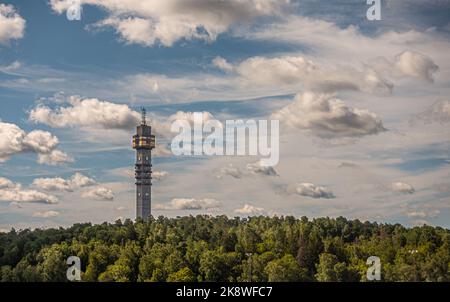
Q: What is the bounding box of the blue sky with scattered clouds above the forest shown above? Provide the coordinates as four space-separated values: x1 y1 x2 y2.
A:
0 0 450 230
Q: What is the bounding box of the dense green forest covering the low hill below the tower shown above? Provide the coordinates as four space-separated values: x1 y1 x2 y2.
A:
0 215 450 282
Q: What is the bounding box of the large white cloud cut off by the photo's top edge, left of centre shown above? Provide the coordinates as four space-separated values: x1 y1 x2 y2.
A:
50 0 289 47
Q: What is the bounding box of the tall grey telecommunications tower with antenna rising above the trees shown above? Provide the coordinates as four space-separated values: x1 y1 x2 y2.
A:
133 108 155 221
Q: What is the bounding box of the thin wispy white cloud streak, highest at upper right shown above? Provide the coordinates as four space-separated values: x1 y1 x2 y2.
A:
246 15 442 63
